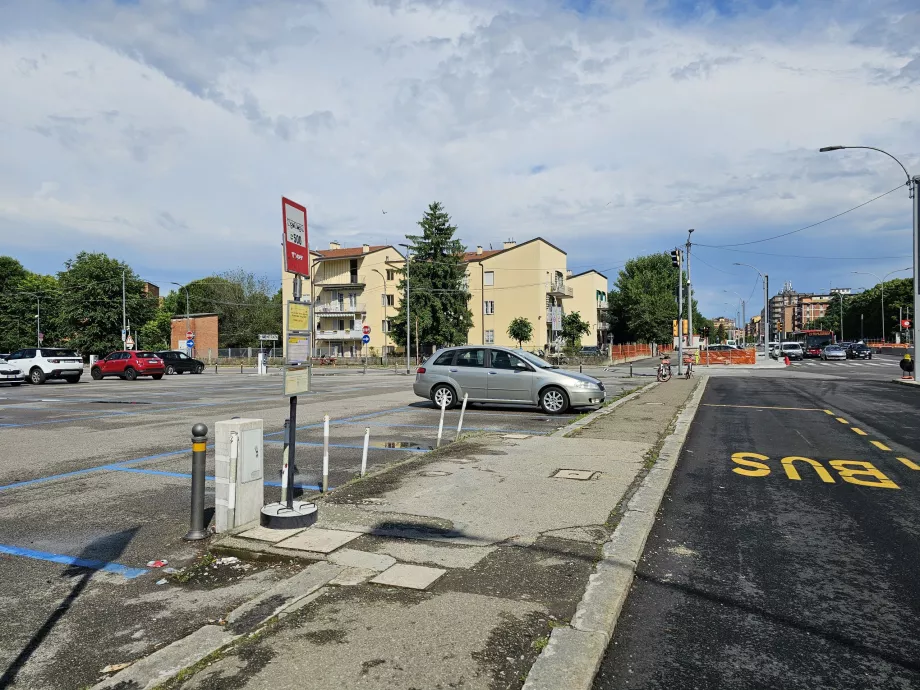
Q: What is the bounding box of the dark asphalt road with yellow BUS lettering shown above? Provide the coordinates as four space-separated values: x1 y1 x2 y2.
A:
595 372 920 690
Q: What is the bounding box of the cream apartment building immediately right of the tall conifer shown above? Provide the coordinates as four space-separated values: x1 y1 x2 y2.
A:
464 237 574 349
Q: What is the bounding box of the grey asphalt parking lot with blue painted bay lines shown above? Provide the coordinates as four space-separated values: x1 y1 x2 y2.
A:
0 370 643 688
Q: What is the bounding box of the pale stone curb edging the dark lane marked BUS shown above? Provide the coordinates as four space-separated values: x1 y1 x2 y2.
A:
522 376 709 690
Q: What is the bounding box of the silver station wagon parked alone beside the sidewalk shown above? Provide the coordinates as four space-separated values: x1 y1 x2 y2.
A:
413 345 607 414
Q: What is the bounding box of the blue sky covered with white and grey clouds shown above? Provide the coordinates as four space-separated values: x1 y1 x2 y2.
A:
0 0 920 316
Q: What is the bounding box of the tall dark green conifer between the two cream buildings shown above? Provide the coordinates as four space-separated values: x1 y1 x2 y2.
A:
389 201 473 351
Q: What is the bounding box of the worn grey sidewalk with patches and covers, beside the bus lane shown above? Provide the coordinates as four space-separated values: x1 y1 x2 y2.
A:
97 379 705 690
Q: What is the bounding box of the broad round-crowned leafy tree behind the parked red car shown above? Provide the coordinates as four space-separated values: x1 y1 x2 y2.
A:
58 252 157 355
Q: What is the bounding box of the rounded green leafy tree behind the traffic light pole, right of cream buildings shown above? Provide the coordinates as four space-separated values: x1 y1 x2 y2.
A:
608 253 710 343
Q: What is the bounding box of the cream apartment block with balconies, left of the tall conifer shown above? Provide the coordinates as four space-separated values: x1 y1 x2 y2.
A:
282 242 405 357
